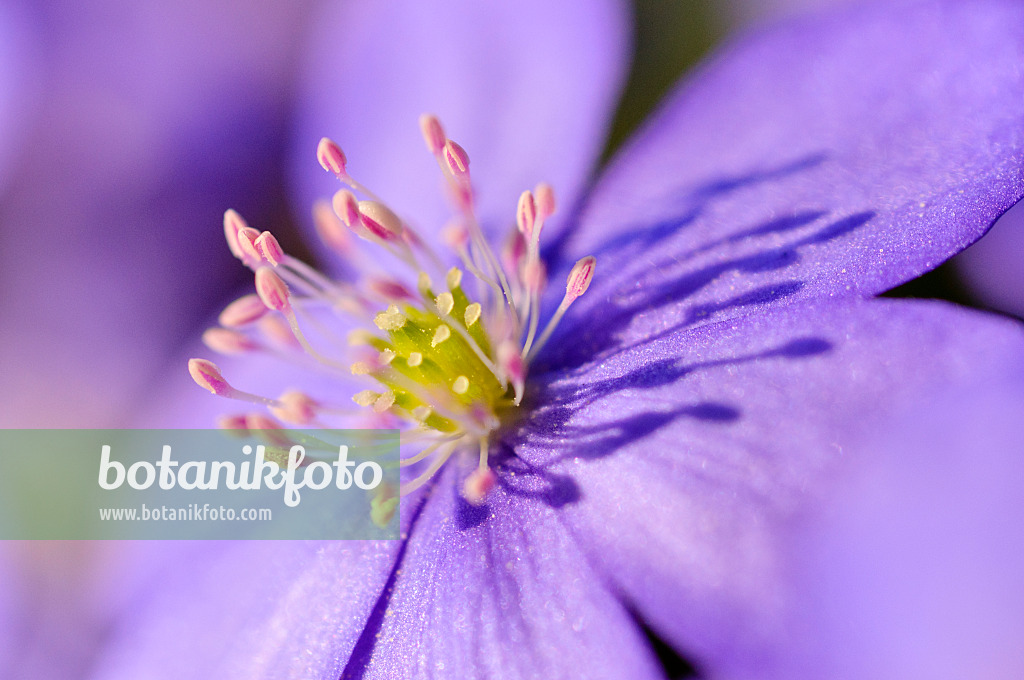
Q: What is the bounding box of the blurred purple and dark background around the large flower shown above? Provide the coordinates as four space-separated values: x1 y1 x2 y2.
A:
0 0 1024 677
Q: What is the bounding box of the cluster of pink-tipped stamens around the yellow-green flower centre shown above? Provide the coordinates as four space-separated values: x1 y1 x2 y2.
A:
188 116 595 507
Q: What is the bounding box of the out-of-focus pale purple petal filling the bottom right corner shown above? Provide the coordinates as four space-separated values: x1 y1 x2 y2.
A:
750 374 1024 680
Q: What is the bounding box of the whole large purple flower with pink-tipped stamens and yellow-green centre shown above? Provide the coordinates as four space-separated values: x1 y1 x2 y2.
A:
0 0 1024 680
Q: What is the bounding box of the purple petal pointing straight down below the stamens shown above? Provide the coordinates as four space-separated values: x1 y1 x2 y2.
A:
346 462 662 679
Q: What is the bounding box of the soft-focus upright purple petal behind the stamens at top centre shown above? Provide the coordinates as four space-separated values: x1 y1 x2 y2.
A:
294 0 628 260
